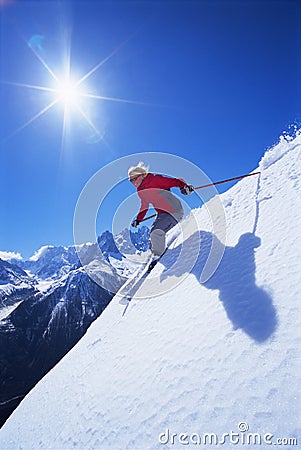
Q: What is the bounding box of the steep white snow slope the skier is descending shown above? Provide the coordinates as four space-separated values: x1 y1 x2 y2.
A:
0 135 301 450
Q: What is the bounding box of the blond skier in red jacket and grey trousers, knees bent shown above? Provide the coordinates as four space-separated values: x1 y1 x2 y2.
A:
128 163 194 270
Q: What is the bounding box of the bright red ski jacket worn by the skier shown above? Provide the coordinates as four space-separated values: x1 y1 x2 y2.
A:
137 173 187 222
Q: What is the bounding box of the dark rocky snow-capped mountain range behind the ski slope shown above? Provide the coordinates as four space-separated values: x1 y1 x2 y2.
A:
0 232 147 425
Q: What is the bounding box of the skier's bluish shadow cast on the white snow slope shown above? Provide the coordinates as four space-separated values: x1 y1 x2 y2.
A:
161 231 277 343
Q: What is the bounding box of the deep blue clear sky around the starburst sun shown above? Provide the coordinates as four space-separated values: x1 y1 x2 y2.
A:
0 0 301 258
